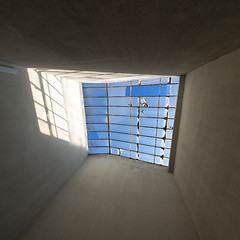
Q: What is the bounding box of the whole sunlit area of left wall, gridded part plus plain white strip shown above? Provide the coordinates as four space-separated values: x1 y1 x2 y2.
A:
28 69 87 148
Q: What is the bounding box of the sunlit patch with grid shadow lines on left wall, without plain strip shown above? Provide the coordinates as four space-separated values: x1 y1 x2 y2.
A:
28 69 70 142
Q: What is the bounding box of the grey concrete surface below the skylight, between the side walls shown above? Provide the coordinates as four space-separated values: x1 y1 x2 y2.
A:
20 155 199 240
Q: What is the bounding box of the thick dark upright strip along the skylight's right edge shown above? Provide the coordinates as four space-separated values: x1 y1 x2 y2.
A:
168 75 186 173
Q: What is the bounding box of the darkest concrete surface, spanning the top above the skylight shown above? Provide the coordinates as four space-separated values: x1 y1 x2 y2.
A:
0 0 240 75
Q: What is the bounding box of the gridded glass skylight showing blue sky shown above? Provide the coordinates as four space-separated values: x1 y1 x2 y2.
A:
83 77 179 166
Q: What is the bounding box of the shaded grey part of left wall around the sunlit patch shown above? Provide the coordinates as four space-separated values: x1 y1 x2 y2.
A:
0 62 87 240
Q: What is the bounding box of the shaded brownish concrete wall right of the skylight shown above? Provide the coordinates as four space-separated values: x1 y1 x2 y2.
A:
175 49 240 240
